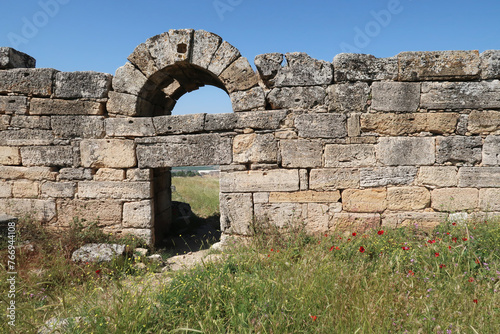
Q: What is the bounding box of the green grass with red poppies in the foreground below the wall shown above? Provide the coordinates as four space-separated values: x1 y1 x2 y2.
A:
0 215 500 333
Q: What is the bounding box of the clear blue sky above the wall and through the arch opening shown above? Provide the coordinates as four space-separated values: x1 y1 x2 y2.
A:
0 0 500 114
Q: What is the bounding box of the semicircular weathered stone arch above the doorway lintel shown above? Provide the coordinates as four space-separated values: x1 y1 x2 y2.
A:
107 29 265 116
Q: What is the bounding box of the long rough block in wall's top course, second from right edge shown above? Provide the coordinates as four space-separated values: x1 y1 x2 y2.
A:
397 50 481 81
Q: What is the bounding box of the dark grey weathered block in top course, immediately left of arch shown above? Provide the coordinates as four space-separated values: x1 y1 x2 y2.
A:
54 71 113 99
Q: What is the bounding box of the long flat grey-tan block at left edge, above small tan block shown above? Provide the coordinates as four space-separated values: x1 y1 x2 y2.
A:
0 129 54 146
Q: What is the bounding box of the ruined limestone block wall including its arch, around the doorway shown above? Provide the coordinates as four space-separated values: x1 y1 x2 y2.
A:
0 30 500 243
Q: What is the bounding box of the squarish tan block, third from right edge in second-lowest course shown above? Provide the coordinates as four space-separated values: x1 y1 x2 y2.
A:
387 187 431 211
